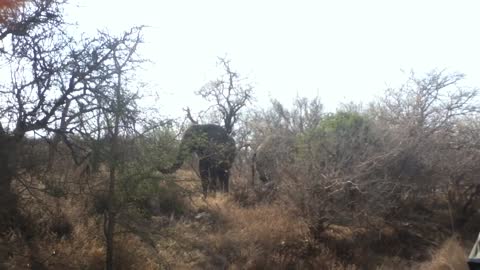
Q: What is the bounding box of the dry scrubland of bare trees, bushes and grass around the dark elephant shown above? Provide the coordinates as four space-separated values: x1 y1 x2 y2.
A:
0 1 480 270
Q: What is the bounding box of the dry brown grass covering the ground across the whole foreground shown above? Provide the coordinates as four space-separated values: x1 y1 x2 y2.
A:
0 168 467 270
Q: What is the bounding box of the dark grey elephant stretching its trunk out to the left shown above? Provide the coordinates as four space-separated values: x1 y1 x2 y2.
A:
159 124 236 196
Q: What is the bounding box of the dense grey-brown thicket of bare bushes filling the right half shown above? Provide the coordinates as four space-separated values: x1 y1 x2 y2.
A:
242 71 480 264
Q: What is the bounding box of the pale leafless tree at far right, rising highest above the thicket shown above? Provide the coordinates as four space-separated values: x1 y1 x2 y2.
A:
357 70 480 225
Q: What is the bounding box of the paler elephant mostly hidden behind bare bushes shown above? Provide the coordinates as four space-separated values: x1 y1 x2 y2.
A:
252 135 295 184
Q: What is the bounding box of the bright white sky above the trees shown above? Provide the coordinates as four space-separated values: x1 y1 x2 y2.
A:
68 0 480 116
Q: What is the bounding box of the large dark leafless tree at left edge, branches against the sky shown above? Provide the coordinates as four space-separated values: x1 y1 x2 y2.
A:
0 0 141 234
